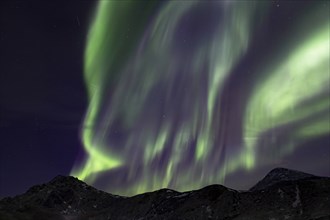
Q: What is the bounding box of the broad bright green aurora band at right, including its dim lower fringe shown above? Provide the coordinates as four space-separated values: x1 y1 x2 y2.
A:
242 5 330 168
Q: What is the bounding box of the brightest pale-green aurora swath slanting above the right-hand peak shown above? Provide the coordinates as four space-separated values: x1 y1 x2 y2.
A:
244 24 330 170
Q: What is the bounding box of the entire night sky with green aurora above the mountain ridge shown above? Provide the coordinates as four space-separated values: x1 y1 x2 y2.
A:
0 0 330 197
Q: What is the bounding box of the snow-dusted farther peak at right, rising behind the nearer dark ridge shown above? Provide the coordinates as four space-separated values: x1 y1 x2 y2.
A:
250 167 315 191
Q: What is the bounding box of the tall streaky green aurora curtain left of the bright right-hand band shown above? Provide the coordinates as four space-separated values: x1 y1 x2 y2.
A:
72 1 257 194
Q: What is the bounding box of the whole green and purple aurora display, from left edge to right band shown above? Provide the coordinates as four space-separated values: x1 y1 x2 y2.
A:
72 1 330 195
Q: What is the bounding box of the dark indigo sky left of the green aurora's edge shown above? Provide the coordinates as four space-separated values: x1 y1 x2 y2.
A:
0 1 95 197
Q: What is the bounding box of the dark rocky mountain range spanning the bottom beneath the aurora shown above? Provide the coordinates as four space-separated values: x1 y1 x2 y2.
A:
0 168 330 220
